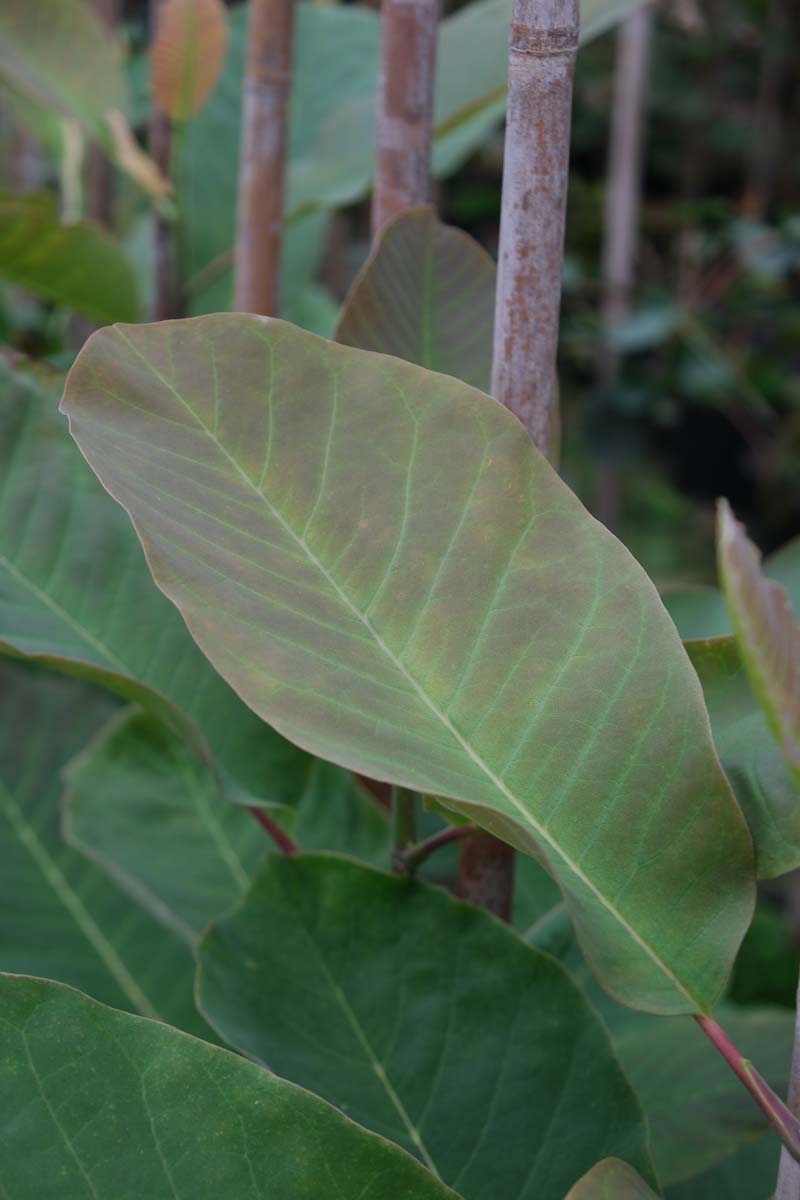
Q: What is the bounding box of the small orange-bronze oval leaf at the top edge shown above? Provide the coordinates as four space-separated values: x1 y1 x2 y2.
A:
150 0 228 121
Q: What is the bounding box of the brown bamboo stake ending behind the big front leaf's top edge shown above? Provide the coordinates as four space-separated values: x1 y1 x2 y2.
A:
234 0 294 317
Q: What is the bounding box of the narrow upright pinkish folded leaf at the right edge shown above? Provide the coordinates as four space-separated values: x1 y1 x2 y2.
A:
717 500 800 784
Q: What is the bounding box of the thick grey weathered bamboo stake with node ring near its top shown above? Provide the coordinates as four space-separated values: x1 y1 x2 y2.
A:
492 0 579 454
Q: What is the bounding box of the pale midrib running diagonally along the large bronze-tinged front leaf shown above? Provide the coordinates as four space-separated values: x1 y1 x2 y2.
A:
113 318 705 1012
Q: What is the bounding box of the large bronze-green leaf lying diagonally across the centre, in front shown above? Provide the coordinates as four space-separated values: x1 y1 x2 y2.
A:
64 314 753 1012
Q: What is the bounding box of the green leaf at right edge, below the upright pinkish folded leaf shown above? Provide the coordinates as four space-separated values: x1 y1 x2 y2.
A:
686 637 800 878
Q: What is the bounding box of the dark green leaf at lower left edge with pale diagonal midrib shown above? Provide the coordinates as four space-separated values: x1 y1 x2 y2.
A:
0 662 205 1032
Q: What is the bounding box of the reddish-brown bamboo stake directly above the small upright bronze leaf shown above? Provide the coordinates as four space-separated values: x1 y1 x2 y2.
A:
372 0 439 239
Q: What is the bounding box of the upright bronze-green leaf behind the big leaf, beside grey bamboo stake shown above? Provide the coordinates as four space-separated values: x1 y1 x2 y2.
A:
335 206 495 391
